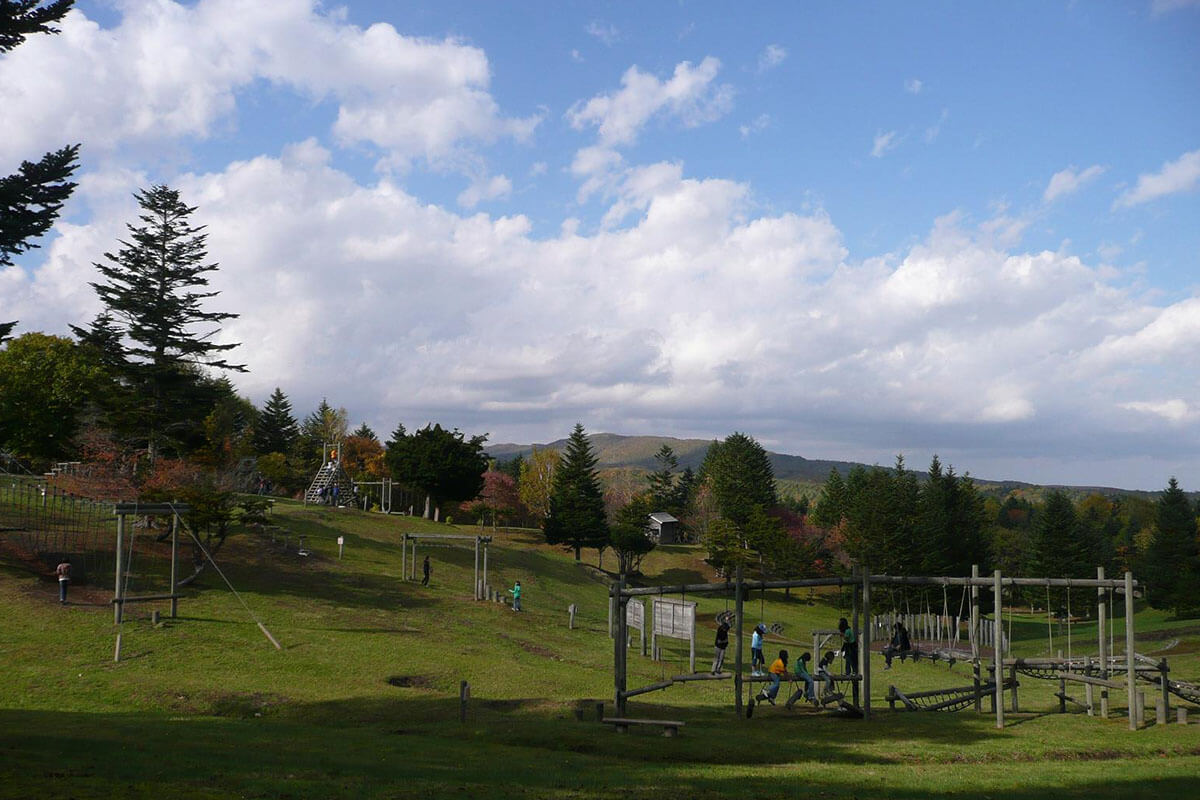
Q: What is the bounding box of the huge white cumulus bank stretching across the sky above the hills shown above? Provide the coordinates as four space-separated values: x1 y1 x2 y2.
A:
9 140 1200 484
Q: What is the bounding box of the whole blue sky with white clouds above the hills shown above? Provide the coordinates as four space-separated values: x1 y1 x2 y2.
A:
0 0 1200 491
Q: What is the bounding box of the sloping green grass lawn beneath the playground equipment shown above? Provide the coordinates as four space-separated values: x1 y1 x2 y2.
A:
0 503 1200 798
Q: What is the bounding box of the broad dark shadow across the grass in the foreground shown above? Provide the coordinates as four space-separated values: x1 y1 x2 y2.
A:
0 705 1195 800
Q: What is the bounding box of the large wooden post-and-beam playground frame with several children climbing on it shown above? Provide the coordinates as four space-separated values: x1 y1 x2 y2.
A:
610 566 1180 730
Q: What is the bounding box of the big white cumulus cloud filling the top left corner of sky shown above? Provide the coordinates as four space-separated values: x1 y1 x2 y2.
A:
0 0 538 167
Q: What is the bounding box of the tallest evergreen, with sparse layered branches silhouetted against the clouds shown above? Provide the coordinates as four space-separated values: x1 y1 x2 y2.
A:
74 186 245 459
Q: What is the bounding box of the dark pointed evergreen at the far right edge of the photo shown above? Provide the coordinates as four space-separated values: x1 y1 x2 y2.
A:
1144 477 1200 613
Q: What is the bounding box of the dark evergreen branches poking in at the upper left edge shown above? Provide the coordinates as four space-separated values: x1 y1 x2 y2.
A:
0 0 79 335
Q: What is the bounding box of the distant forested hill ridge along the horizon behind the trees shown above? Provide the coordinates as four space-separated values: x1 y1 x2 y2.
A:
485 433 1180 501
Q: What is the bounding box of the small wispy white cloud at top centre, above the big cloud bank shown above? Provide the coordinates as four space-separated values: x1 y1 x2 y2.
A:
566 56 733 146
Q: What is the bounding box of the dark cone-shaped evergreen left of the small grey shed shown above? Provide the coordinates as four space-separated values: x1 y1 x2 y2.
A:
542 423 608 561
